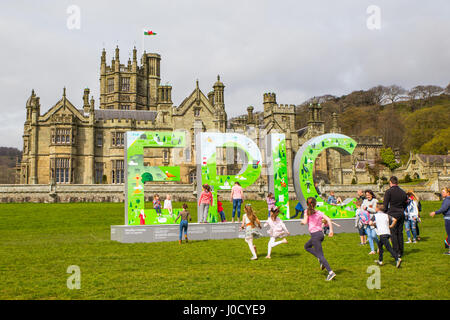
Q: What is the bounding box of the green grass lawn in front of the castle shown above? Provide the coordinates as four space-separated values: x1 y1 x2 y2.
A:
0 201 450 300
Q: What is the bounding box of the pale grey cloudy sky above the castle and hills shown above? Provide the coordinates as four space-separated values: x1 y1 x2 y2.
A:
0 0 450 149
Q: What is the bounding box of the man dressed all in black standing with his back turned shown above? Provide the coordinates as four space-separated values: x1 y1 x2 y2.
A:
383 176 408 257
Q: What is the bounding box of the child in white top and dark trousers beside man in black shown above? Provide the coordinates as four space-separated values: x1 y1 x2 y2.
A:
369 203 402 268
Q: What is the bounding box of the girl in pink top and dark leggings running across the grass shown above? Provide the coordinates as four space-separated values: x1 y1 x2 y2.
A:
301 197 336 281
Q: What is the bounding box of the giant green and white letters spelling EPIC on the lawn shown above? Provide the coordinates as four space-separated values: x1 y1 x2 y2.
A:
125 131 356 225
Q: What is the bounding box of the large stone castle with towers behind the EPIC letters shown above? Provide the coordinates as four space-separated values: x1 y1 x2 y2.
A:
17 48 383 185
